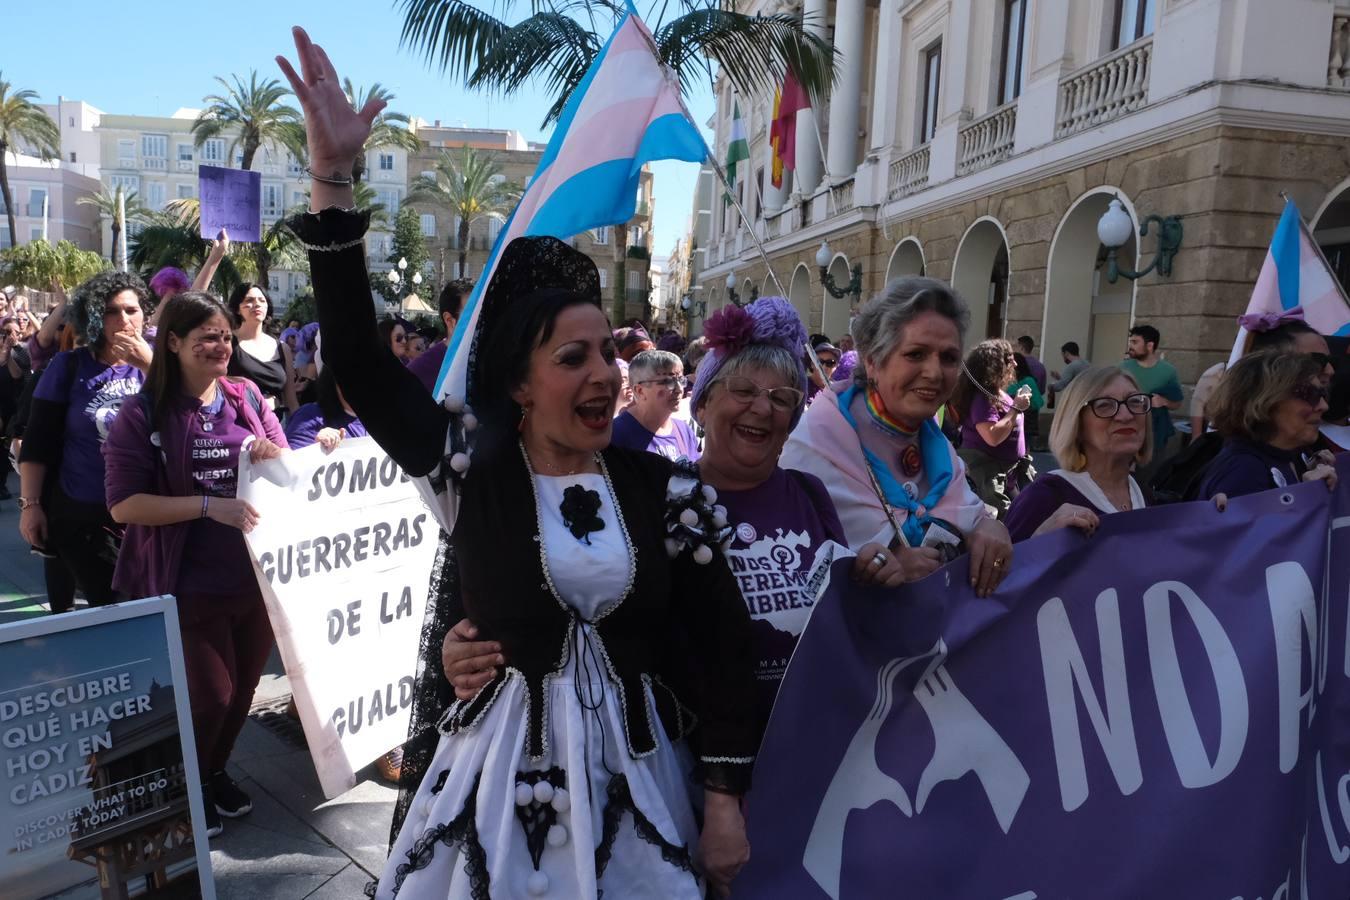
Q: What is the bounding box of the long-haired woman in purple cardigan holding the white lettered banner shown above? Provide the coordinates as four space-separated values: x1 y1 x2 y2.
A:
104 291 286 835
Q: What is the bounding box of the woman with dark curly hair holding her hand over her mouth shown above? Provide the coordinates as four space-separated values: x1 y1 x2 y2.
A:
19 271 151 606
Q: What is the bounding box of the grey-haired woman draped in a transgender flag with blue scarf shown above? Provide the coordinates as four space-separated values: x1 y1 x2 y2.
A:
783 278 1013 596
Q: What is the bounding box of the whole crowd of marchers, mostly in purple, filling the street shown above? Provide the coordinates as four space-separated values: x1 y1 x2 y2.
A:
0 22 1350 899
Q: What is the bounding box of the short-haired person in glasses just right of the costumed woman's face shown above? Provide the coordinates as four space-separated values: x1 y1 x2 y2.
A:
610 349 699 463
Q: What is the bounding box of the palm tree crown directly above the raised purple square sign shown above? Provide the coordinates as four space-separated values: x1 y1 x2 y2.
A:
192 70 305 169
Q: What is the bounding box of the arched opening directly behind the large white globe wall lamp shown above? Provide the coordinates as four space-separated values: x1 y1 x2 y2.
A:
1041 188 1139 368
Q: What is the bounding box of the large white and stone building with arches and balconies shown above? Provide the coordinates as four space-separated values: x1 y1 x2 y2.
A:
698 0 1350 391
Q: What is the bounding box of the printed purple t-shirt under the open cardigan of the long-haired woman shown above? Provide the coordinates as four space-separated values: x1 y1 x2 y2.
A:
176 390 258 596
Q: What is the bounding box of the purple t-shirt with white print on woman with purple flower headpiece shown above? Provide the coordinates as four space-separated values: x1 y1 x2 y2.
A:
717 468 846 734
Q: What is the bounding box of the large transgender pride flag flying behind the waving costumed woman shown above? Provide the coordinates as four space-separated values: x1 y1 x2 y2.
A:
435 5 707 399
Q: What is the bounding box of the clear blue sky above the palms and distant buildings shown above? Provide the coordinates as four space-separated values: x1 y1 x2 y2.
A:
0 0 713 255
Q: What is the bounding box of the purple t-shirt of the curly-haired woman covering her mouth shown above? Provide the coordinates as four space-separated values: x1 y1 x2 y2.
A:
32 347 146 503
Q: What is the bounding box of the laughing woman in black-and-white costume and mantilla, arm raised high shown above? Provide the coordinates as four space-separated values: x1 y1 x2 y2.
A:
278 28 755 900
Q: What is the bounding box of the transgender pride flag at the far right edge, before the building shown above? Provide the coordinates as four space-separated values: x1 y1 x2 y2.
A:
1229 201 1350 366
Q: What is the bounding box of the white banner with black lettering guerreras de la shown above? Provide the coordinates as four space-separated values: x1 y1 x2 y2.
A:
239 437 437 797
